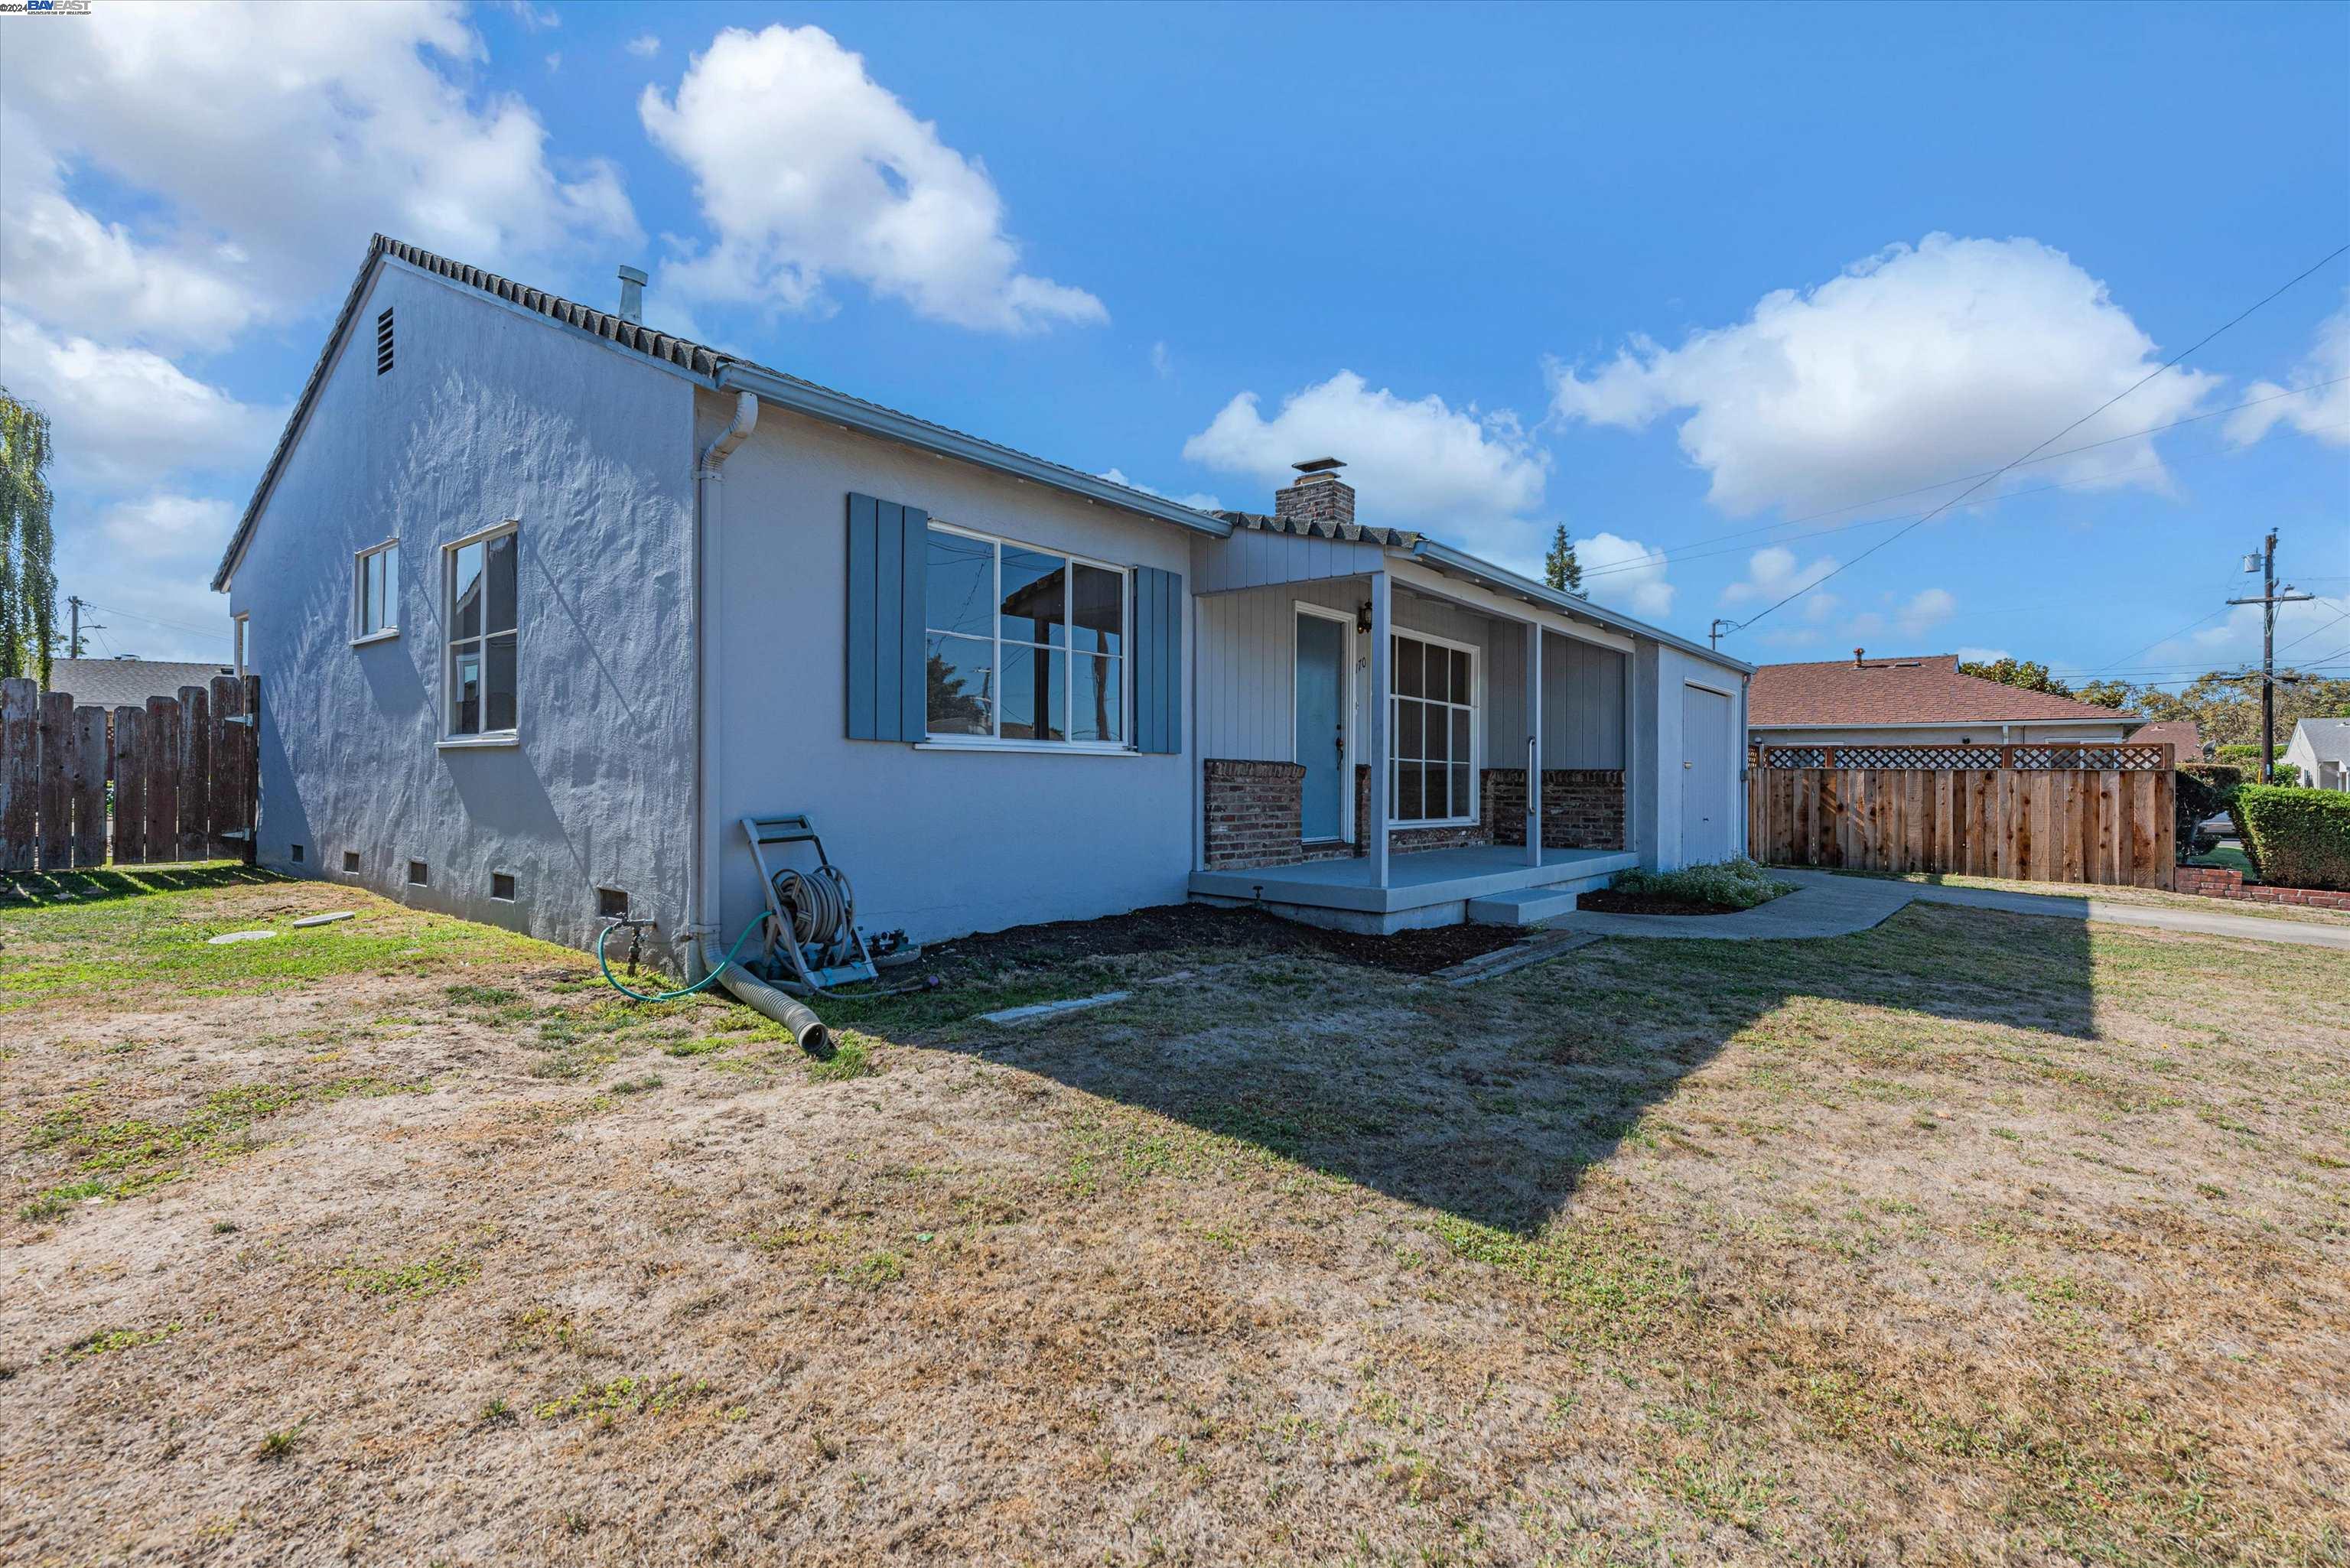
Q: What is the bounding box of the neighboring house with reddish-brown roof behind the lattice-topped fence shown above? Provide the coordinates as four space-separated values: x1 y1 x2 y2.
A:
1746 649 2146 745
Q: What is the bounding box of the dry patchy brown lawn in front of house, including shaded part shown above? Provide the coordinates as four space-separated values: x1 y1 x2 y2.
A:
0 874 2350 1563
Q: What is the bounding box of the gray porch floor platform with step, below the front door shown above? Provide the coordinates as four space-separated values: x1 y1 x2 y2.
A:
1192 844 1640 935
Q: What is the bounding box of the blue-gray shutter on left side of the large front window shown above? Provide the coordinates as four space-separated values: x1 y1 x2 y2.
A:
844 496 931 740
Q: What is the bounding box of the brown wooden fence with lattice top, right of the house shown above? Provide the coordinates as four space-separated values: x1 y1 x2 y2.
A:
1746 745 2179 889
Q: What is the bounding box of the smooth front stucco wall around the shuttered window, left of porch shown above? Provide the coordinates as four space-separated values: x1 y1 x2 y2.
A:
700 395 1196 940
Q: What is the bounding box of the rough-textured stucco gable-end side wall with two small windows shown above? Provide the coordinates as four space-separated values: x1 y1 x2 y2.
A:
230 261 693 945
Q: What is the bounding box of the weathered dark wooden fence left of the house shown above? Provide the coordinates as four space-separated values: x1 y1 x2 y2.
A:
0 675 261 872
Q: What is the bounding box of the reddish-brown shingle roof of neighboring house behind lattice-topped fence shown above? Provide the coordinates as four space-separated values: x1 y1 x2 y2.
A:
1746 653 2134 729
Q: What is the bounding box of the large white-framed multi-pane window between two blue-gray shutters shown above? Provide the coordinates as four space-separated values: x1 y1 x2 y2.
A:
923 522 1133 747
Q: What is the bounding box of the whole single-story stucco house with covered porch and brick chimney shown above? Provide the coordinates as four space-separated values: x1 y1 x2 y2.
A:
214 237 1749 968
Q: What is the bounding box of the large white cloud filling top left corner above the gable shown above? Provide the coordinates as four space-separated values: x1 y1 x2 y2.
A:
0 5 642 346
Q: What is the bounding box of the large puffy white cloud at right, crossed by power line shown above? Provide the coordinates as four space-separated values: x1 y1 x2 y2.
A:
1551 233 2218 515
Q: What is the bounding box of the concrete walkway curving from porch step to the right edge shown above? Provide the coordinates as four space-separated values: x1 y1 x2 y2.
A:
1541 870 2350 952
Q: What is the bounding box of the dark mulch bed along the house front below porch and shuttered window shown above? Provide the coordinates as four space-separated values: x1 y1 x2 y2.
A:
921 903 1518 975
